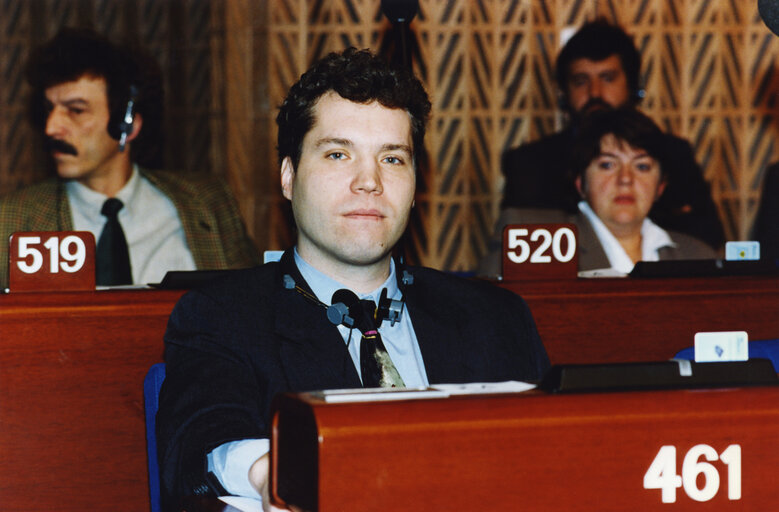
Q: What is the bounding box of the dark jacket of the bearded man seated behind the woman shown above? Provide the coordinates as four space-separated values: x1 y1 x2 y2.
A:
501 127 725 249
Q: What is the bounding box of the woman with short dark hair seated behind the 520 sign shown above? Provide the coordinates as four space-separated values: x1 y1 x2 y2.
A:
479 108 716 276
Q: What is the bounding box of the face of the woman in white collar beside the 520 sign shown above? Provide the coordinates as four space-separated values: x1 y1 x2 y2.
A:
576 134 665 234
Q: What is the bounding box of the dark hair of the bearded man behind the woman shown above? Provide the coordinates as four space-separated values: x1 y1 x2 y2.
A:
555 18 641 109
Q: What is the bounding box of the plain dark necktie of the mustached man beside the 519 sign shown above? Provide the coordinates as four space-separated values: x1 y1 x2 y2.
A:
95 197 133 286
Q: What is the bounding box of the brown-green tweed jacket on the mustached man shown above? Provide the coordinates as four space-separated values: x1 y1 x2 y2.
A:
0 169 260 289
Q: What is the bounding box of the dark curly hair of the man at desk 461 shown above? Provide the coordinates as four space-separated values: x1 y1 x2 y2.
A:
276 48 430 170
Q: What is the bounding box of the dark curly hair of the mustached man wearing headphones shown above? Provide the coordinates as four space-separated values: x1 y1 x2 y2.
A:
25 28 164 167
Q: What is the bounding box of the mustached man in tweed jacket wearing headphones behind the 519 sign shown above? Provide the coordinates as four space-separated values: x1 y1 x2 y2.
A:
0 29 259 288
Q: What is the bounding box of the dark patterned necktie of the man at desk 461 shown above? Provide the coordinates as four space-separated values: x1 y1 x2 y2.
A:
354 300 405 388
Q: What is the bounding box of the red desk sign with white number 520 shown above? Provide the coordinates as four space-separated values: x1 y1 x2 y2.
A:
503 224 579 281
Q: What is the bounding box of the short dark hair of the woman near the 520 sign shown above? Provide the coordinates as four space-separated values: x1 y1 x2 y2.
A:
570 107 669 179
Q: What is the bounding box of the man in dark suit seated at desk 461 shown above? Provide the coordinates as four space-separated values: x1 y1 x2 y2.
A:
157 49 549 509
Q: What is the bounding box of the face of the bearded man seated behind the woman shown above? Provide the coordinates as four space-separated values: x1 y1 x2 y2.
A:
566 54 630 116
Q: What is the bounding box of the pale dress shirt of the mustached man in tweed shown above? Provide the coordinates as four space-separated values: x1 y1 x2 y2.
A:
65 166 196 284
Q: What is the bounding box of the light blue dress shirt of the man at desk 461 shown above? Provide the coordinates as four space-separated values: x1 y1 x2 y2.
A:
208 248 428 499
